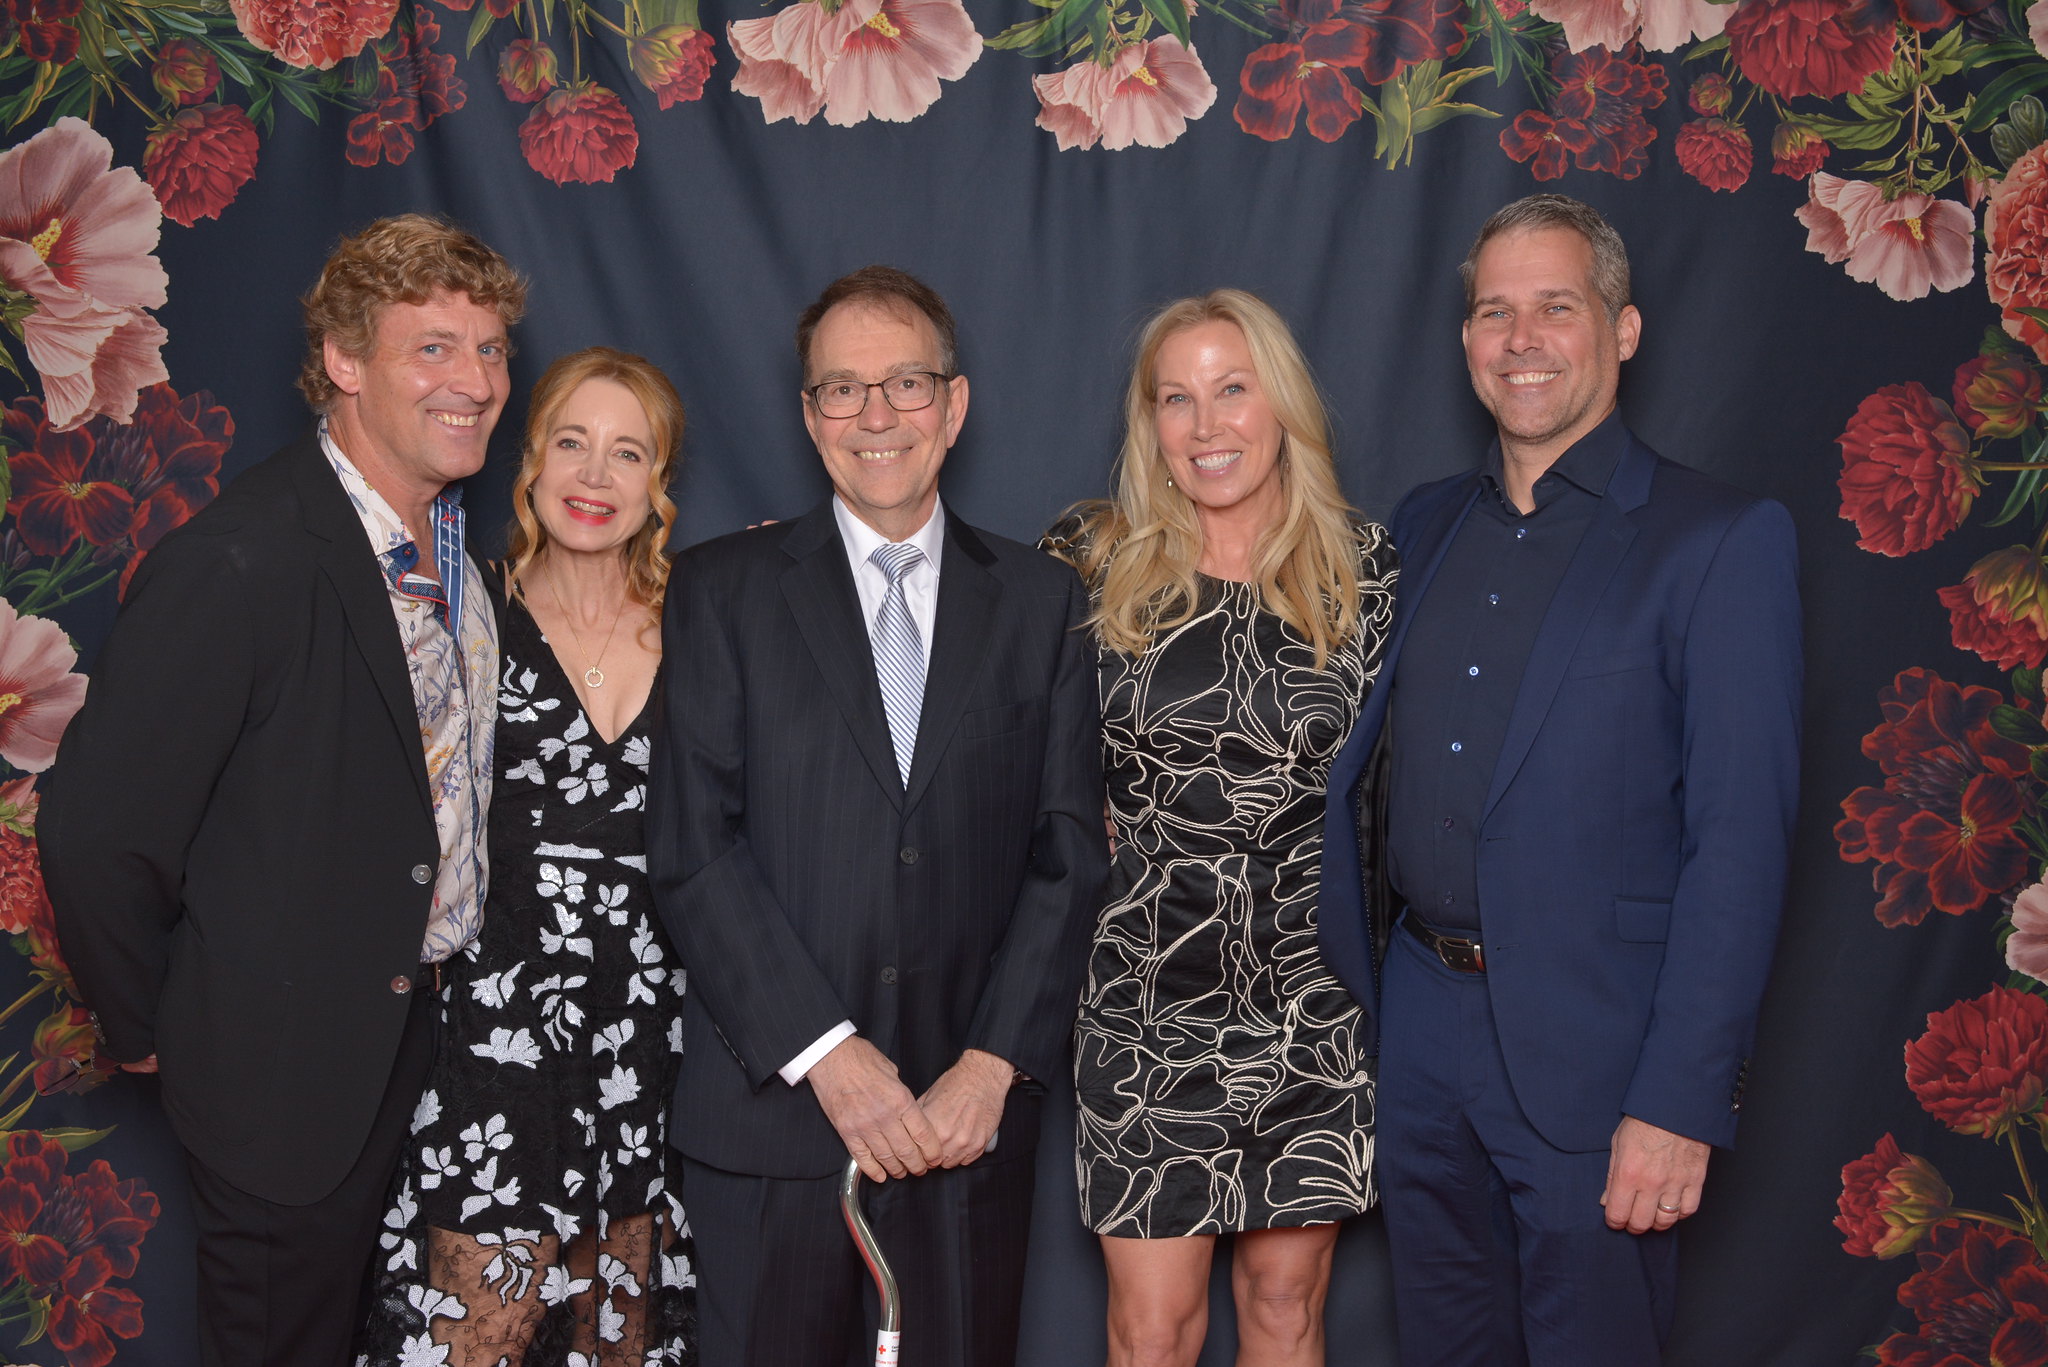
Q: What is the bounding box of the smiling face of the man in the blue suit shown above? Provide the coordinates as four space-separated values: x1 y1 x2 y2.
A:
1464 227 1642 465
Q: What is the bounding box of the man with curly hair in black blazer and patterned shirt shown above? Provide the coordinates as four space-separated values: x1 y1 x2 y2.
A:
39 215 526 1367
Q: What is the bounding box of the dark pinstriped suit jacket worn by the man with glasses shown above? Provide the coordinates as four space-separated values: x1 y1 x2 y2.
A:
647 500 1108 1176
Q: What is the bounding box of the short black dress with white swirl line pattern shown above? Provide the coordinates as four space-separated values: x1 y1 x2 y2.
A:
1051 525 1395 1238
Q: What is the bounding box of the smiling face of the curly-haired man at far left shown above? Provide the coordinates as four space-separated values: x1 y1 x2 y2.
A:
326 291 512 516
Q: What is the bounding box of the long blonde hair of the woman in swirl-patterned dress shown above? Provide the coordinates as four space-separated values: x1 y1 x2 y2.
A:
1069 289 1360 668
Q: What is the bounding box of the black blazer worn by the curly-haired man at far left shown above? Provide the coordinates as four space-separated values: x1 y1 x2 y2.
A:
37 437 438 1203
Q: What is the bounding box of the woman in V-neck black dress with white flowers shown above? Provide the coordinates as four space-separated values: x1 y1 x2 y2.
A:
372 346 696 1367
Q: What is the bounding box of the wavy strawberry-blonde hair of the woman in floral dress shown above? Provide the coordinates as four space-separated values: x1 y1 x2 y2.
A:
506 346 682 631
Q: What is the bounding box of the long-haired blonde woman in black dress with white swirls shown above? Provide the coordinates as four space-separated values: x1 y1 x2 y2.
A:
1047 289 1395 1367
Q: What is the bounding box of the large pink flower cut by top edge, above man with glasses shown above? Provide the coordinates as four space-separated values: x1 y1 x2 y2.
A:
725 0 981 127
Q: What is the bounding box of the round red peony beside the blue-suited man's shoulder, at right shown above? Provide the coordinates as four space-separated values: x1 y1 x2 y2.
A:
1835 381 1982 555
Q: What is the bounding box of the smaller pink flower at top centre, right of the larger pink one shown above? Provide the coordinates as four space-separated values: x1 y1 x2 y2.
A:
1030 37 1217 152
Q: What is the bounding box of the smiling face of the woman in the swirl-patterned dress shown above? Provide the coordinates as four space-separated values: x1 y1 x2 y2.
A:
1151 318 1286 527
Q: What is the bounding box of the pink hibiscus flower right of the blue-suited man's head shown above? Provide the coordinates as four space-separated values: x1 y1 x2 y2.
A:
1794 170 1976 299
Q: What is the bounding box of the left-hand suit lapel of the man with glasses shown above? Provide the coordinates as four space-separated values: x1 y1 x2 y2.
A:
782 498 905 807
